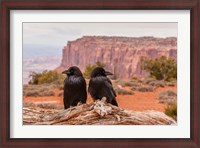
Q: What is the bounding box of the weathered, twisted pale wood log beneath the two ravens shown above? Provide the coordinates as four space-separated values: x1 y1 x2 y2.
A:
23 99 176 125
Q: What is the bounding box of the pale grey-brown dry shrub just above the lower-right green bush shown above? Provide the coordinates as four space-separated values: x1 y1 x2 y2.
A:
159 90 177 104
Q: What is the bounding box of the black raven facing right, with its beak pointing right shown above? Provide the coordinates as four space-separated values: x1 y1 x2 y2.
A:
88 67 118 106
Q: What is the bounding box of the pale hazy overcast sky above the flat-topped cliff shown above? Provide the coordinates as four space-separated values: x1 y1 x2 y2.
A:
23 23 178 48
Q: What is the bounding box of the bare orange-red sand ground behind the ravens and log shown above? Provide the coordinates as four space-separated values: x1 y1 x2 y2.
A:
24 86 177 112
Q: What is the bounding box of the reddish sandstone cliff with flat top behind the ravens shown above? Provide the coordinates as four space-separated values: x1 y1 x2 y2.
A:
57 36 177 78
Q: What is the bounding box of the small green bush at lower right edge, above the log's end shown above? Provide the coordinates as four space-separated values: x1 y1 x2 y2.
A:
165 102 177 120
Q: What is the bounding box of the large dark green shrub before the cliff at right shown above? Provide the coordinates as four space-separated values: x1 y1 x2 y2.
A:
141 56 177 81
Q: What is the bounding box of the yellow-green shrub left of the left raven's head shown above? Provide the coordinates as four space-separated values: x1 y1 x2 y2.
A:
29 70 66 84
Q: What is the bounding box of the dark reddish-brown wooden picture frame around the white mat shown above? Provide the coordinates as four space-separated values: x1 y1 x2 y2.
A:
0 0 200 148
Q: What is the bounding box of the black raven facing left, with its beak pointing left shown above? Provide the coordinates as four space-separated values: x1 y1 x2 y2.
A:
62 66 87 109
